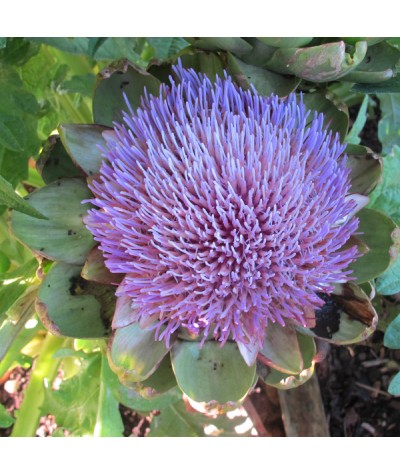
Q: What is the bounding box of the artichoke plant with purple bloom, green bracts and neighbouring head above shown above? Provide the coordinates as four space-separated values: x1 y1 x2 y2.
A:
11 38 399 408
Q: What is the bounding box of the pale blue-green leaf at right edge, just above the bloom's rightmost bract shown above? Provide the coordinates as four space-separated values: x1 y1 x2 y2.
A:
369 146 400 225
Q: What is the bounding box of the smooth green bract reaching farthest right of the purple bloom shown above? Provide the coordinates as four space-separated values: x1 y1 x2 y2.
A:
349 208 398 284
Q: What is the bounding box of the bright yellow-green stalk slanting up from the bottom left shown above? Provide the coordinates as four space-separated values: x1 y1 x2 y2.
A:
11 333 65 437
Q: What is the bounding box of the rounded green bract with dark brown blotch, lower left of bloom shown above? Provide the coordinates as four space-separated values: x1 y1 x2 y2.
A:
36 262 115 338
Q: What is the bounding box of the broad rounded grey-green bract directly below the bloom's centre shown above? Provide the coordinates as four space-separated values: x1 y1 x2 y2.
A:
171 341 255 404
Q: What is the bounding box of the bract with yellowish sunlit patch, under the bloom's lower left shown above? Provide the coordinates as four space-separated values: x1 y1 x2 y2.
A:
108 323 169 386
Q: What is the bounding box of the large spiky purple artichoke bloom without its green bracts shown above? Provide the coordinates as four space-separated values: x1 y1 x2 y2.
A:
87 66 358 354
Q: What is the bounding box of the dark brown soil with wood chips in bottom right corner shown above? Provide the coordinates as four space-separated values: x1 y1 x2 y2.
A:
317 332 400 437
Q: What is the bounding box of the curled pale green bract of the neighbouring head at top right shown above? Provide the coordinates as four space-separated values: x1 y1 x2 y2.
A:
266 41 367 82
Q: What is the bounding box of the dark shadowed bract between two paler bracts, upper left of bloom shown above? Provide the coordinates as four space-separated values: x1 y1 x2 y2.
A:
36 135 85 184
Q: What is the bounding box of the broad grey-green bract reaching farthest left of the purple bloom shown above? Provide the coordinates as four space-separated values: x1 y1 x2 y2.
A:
11 178 94 264
